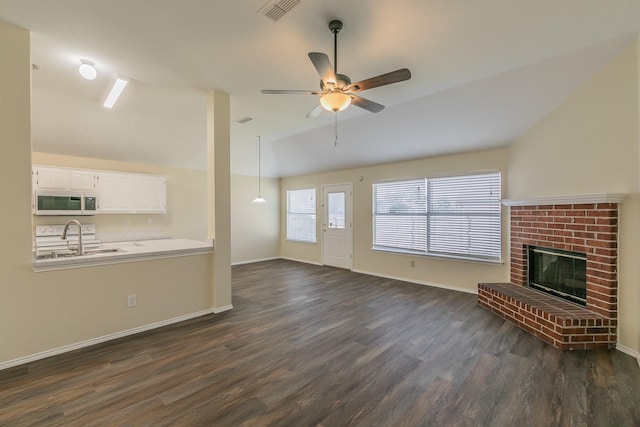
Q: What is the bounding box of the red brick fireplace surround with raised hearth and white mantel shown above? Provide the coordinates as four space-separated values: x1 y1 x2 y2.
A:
478 194 624 350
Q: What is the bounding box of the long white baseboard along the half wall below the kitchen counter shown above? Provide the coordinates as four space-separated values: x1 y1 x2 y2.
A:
0 305 220 371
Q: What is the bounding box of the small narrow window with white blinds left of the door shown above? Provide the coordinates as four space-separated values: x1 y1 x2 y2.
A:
287 188 316 243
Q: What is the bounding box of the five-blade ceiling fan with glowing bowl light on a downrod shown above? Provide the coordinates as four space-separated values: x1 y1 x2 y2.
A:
262 19 411 117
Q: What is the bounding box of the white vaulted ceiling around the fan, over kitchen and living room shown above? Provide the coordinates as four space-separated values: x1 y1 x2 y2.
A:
0 0 640 177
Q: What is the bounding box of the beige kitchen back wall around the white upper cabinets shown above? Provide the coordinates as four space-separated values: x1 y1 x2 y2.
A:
32 152 207 240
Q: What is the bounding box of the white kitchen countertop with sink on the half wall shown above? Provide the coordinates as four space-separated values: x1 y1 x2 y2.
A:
33 239 213 272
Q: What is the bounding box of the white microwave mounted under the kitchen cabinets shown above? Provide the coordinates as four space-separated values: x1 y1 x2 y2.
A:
33 190 97 215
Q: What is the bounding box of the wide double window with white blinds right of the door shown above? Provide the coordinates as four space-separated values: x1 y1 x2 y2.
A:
373 172 501 261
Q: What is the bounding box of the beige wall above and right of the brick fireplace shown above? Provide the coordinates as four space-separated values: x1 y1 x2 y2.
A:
506 38 640 352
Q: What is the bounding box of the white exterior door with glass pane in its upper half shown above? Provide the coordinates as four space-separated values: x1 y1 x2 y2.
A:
322 183 353 270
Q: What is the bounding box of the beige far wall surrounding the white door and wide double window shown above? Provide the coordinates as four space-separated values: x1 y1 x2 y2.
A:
280 149 509 292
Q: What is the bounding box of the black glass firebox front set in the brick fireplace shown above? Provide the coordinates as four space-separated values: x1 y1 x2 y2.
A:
529 246 587 305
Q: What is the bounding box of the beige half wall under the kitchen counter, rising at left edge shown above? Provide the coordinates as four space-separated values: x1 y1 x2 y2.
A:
0 22 225 368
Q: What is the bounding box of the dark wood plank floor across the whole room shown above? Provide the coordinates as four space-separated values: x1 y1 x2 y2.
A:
0 260 640 427
